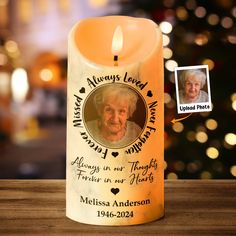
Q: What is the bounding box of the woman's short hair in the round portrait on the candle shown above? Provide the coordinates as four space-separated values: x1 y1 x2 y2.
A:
94 84 138 117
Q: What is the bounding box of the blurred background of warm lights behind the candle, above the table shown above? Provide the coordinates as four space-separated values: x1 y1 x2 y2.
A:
0 0 236 179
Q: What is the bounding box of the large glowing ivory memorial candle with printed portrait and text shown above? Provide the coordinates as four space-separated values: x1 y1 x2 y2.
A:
66 16 164 225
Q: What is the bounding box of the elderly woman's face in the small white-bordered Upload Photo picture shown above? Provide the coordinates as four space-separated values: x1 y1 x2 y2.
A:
184 76 201 101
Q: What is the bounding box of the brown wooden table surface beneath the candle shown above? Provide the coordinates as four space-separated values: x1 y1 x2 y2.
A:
0 180 236 236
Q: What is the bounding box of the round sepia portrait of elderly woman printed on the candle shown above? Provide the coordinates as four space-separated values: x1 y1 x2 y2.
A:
83 83 147 148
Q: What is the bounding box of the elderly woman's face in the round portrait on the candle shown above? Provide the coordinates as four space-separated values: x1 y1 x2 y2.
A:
101 96 129 135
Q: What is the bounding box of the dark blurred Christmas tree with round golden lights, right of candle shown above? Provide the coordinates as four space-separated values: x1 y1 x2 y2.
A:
120 0 236 179
